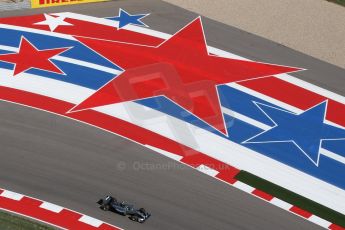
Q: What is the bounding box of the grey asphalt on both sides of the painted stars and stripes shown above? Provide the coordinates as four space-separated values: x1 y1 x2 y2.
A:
0 0 345 229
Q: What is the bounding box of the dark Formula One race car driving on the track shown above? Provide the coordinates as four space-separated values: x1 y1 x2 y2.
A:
97 196 151 223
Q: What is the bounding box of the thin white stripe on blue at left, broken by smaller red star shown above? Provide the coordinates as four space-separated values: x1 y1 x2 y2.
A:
0 45 122 75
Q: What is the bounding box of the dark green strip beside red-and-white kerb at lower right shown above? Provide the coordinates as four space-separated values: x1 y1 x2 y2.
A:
235 171 345 227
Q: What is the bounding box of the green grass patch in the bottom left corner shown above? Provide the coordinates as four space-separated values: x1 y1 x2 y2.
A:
0 211 55 230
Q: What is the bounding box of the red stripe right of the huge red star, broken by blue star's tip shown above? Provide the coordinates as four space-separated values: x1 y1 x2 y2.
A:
238 77 345 126
